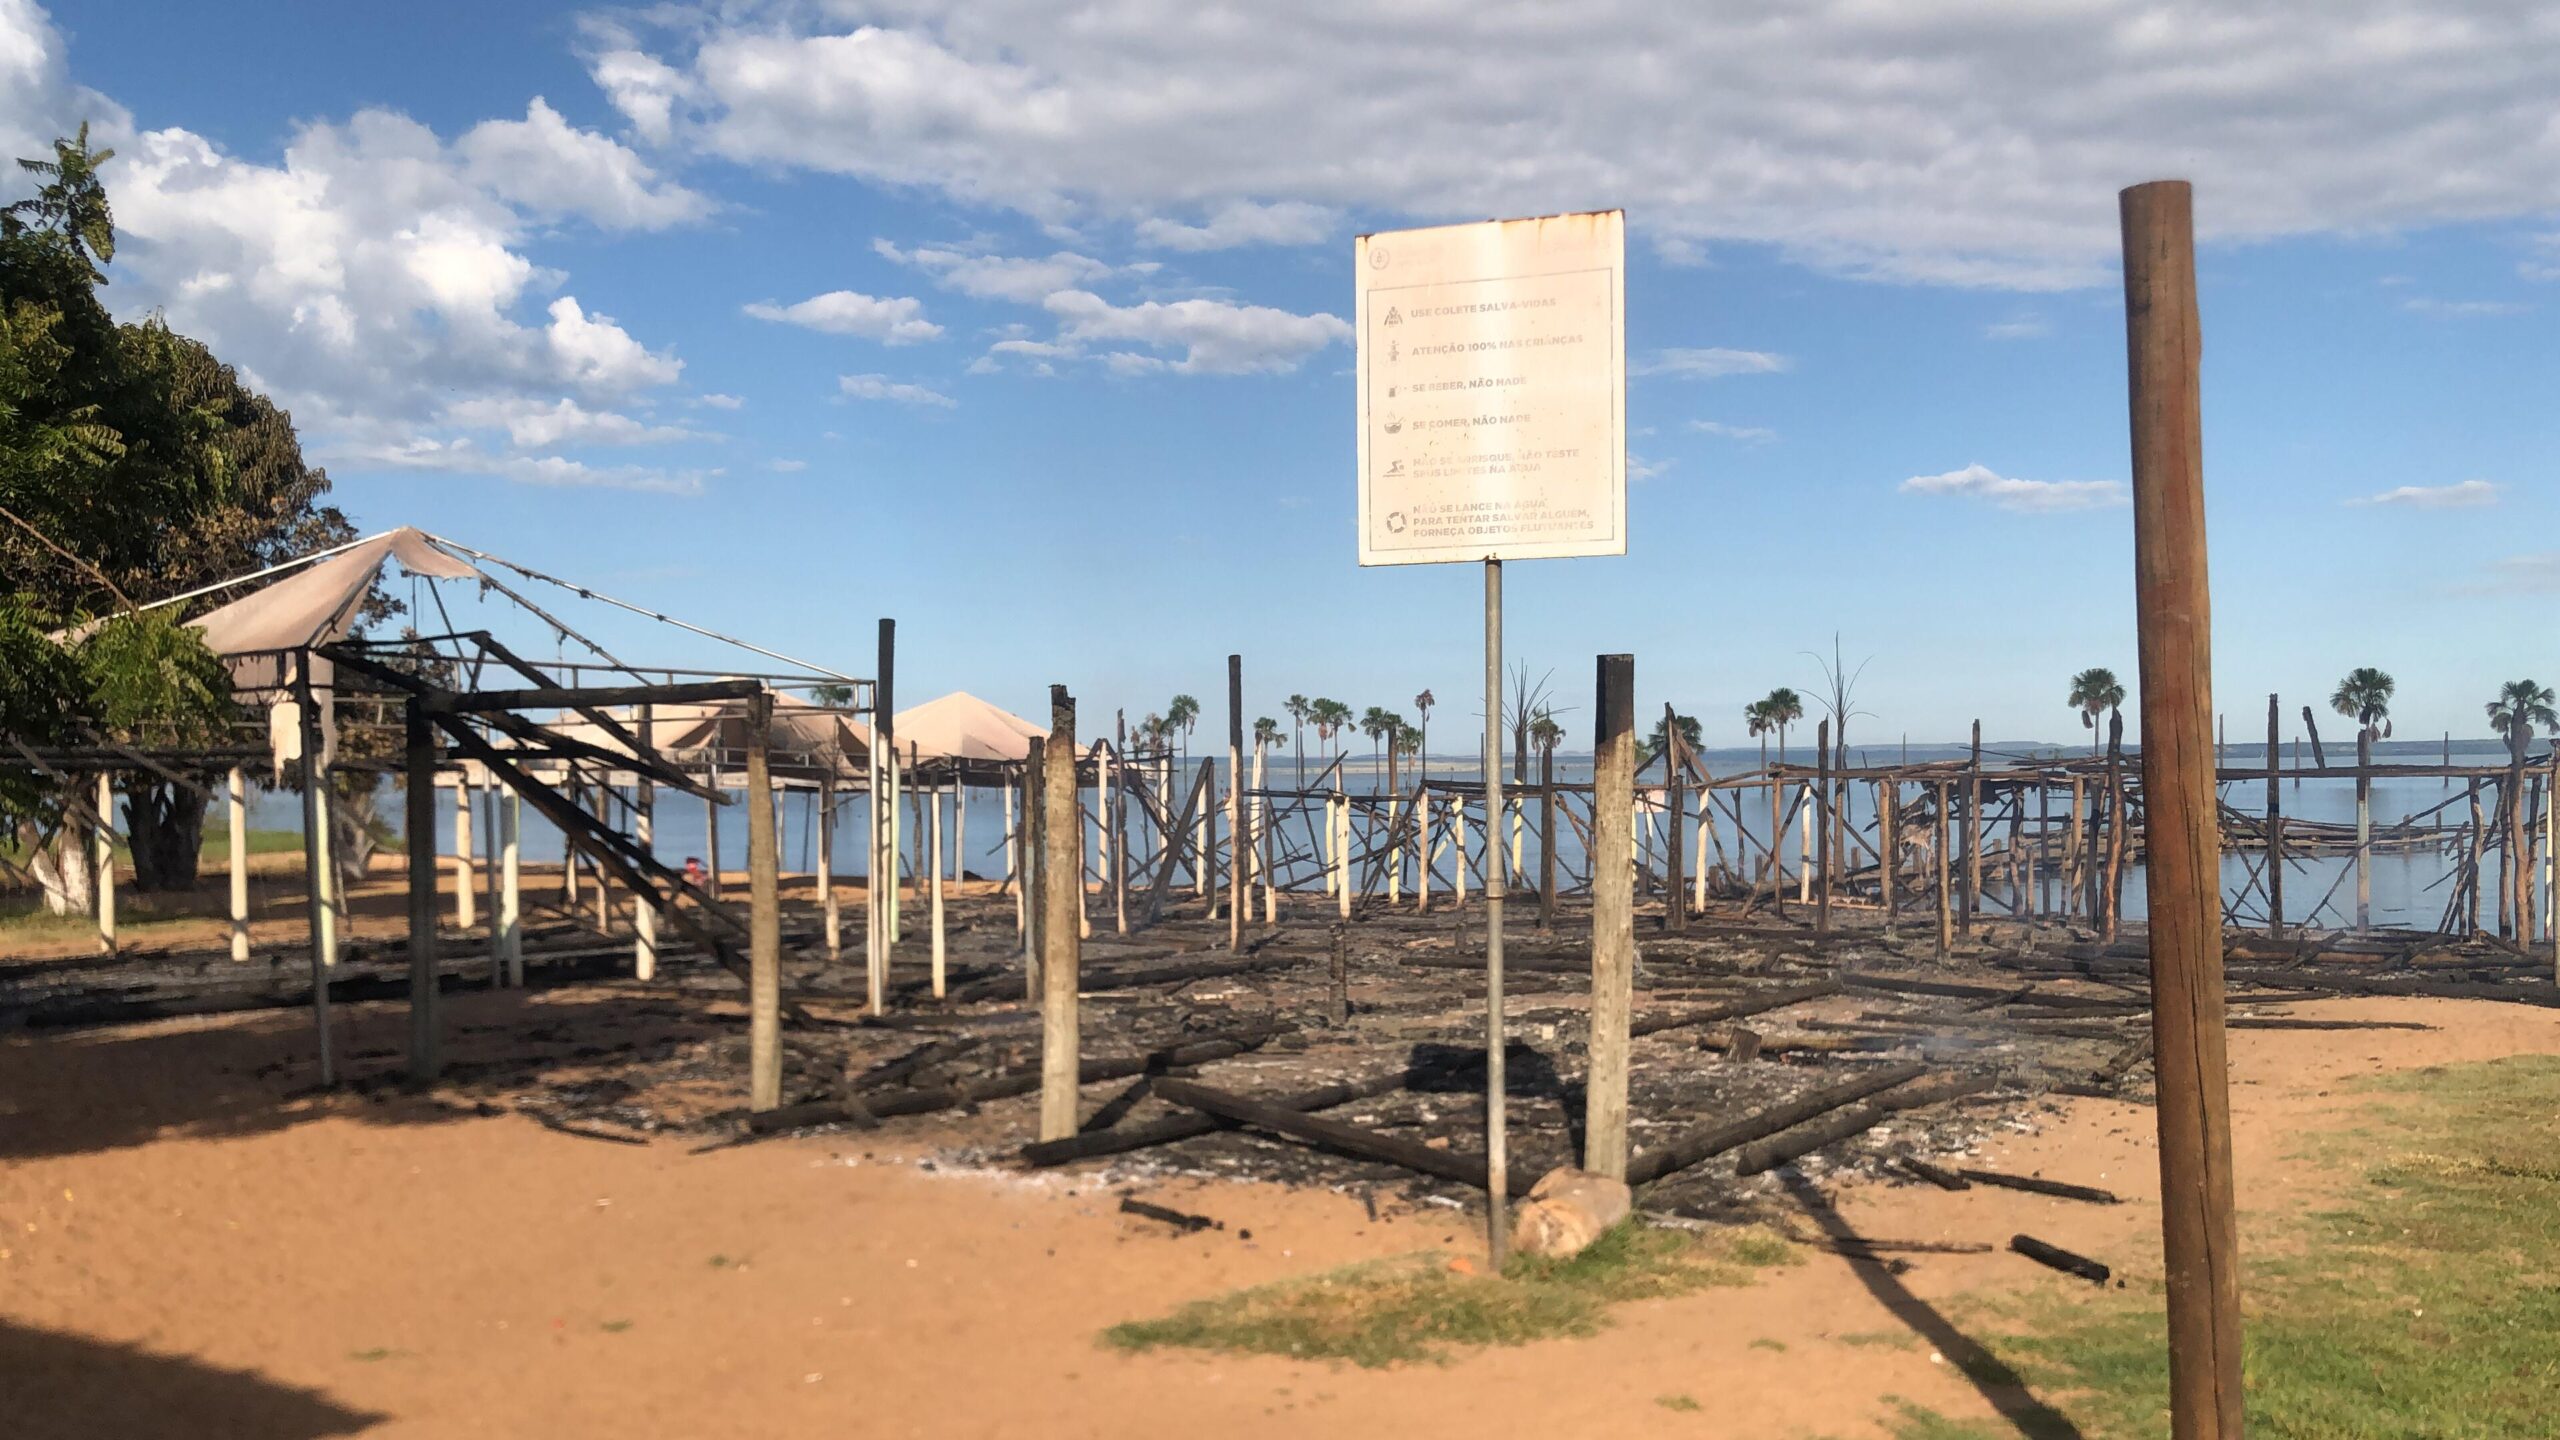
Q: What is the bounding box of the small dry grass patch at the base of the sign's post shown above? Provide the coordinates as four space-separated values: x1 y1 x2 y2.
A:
1103 1222 1748 1366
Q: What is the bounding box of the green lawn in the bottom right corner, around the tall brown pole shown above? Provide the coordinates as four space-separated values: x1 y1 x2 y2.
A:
1897 1056 2560 1440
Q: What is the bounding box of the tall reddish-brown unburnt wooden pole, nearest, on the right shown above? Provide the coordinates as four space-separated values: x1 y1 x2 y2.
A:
2122 179 2240 1440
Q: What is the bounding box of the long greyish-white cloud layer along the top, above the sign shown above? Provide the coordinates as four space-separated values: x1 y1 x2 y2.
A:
591 0 2560 287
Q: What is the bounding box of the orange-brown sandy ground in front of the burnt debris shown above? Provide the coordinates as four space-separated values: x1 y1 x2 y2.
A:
0 994 2560 1440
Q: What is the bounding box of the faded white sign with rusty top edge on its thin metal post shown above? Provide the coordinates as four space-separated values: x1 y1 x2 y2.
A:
1352 210 1626 1271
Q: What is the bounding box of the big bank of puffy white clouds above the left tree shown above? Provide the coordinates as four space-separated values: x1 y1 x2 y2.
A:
0 0 707 489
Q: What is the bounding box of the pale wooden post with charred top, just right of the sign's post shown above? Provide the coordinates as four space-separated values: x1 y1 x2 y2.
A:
1582 656 1638 1179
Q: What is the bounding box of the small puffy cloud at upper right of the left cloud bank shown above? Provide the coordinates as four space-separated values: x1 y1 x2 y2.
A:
453 95 712 231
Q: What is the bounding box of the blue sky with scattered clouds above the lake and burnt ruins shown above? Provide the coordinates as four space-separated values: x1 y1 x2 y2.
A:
0 0 2560 751
